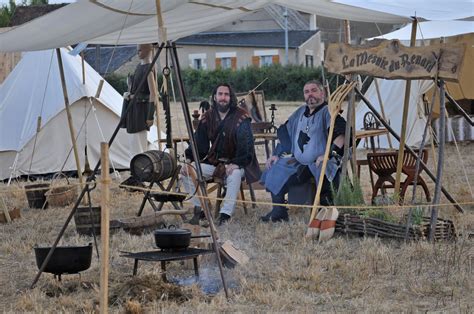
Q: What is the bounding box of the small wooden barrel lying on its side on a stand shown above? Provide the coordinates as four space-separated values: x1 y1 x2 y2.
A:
130 150 176 182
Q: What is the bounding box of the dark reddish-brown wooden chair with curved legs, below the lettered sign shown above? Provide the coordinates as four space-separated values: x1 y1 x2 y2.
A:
367 150 431 203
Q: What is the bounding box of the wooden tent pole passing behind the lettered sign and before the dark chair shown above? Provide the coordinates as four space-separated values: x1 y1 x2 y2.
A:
395 17 418 200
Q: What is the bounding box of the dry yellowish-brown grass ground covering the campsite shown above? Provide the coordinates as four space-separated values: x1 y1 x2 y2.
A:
0 104 474 313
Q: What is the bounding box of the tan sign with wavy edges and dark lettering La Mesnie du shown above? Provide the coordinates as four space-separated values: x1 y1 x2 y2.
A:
324 40 465 82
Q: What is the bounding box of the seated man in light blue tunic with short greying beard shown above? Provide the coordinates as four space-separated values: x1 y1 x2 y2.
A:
260 81 346 222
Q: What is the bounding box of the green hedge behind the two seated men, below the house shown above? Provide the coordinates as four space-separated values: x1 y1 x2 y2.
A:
106 64 335 101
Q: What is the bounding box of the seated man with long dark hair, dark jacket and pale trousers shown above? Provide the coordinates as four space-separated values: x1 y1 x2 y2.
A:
181 84 260 225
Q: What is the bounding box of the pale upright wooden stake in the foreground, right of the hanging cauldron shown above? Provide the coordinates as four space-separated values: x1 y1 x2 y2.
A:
100 142 110 313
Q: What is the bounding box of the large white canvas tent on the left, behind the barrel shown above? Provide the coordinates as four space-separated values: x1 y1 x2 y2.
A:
0 49 150 179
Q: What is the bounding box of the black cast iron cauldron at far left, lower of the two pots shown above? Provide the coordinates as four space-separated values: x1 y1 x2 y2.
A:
34 243 92 279
